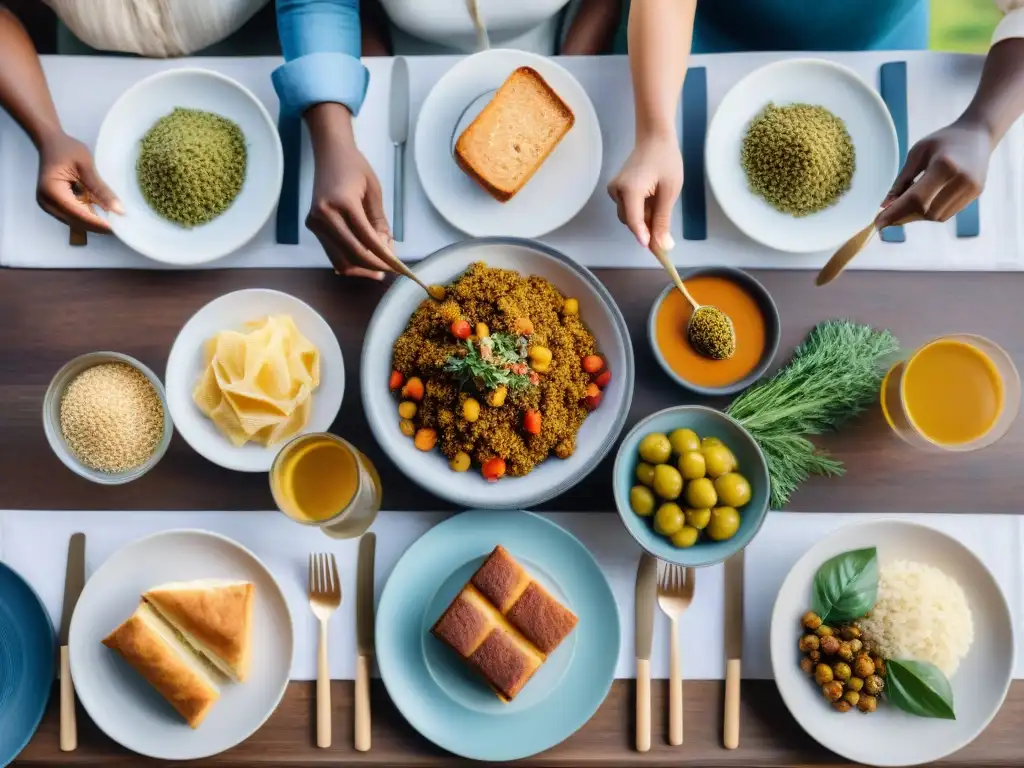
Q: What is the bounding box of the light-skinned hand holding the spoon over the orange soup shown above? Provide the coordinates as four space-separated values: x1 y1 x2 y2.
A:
608 135 683 251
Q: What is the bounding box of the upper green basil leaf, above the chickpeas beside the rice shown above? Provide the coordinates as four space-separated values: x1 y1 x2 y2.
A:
811 547 879 624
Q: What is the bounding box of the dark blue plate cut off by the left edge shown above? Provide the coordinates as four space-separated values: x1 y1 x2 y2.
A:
0 562 57 765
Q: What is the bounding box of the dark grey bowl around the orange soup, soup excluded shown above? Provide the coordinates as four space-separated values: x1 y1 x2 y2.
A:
647 266 782 396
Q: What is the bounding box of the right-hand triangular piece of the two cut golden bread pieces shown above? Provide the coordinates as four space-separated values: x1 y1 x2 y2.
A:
142 579 256 683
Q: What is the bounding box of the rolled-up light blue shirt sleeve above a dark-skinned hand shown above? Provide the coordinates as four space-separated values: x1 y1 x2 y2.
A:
271 0 370 116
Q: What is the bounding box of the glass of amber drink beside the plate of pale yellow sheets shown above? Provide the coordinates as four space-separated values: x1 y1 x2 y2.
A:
270 432 382 539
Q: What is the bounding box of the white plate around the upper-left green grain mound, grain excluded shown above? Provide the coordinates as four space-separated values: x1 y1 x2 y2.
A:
95 69 285 265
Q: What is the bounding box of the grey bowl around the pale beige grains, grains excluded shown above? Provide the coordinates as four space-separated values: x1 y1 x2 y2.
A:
43 352 174 485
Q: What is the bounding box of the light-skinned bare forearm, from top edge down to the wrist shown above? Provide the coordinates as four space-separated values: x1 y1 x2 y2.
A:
629 0 696 139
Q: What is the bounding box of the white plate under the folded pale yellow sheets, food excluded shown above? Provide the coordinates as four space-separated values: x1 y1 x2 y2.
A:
164 288 345 472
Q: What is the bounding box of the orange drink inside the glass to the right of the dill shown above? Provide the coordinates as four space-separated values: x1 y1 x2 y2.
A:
901 339 1004 445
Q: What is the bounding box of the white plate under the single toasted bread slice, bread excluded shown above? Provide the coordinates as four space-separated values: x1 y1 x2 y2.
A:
414 49 601 238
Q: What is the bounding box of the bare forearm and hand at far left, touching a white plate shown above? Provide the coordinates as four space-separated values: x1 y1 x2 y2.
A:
0 6 124 232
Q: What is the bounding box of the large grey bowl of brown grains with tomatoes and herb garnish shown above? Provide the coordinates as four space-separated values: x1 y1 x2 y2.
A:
360 238 633 509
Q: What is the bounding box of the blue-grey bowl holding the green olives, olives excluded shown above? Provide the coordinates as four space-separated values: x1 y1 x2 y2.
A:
613 406 770 568
